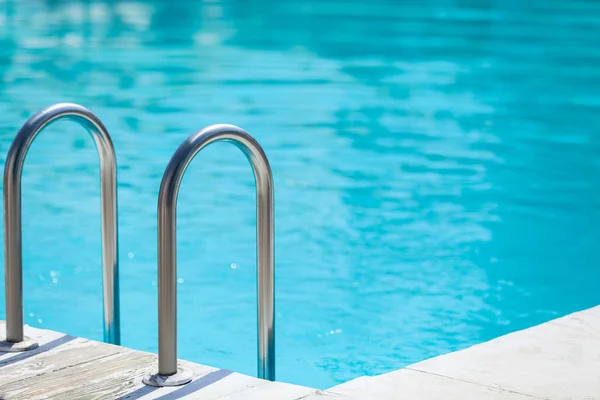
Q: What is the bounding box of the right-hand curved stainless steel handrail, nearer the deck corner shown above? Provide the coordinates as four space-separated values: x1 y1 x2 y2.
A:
144 125 275 386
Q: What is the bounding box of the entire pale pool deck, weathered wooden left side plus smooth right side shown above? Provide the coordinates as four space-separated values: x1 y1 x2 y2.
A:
0 306 600 400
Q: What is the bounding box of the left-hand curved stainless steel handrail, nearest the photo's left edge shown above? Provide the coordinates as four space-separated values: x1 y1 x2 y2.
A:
0 103 120 351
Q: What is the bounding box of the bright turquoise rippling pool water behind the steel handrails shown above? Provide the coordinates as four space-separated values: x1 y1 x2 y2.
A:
0 0 600 388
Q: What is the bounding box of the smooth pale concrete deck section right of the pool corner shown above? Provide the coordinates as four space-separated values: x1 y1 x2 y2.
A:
329 306 600 400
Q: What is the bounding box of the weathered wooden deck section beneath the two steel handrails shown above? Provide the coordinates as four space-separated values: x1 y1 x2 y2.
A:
0 322 317 400
